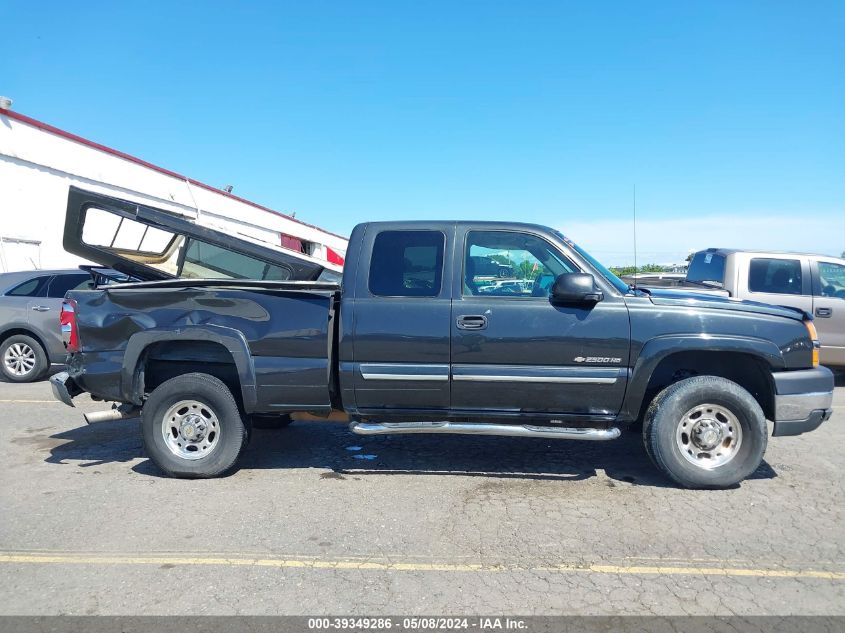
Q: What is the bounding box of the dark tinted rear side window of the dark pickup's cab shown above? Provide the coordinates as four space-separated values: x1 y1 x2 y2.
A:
370 231 446 297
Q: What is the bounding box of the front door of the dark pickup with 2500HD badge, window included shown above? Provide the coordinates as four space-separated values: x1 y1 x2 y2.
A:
451 228 630 416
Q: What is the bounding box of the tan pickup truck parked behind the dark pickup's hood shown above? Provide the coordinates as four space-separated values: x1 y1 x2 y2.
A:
684 248 845 369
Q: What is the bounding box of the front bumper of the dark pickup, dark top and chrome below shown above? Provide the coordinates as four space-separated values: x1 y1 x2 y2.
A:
772 367 833 437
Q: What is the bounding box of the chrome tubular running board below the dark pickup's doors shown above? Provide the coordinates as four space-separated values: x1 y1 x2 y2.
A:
349 422 622 441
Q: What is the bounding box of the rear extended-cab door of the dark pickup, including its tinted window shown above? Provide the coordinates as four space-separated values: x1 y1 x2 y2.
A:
340 222 455 414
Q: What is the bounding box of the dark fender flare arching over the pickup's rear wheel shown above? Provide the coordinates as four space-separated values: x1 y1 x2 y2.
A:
120 324 258 413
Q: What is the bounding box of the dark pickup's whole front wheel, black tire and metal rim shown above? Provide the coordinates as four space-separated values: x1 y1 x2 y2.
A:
643 376 768 489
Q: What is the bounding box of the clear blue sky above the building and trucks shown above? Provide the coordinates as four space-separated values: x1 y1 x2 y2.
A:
0 0 845 264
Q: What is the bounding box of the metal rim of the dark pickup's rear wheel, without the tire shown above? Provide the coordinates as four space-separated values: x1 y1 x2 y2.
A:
161 400 220 460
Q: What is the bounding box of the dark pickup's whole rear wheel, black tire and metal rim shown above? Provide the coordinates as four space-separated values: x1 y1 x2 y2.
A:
141 373 248 479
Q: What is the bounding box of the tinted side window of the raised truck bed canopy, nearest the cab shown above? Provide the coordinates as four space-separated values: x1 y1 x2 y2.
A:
180 239 291 281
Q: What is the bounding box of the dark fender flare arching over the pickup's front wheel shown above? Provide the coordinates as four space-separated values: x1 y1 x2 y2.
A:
620 334 784 420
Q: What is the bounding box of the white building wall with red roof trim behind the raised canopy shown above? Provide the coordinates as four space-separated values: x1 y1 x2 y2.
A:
0 112 347 271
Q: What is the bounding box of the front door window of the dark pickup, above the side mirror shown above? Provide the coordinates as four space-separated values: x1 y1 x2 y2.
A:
463 231 578 297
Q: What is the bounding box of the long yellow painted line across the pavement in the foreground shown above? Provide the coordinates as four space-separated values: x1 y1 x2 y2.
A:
0 553 845 580
